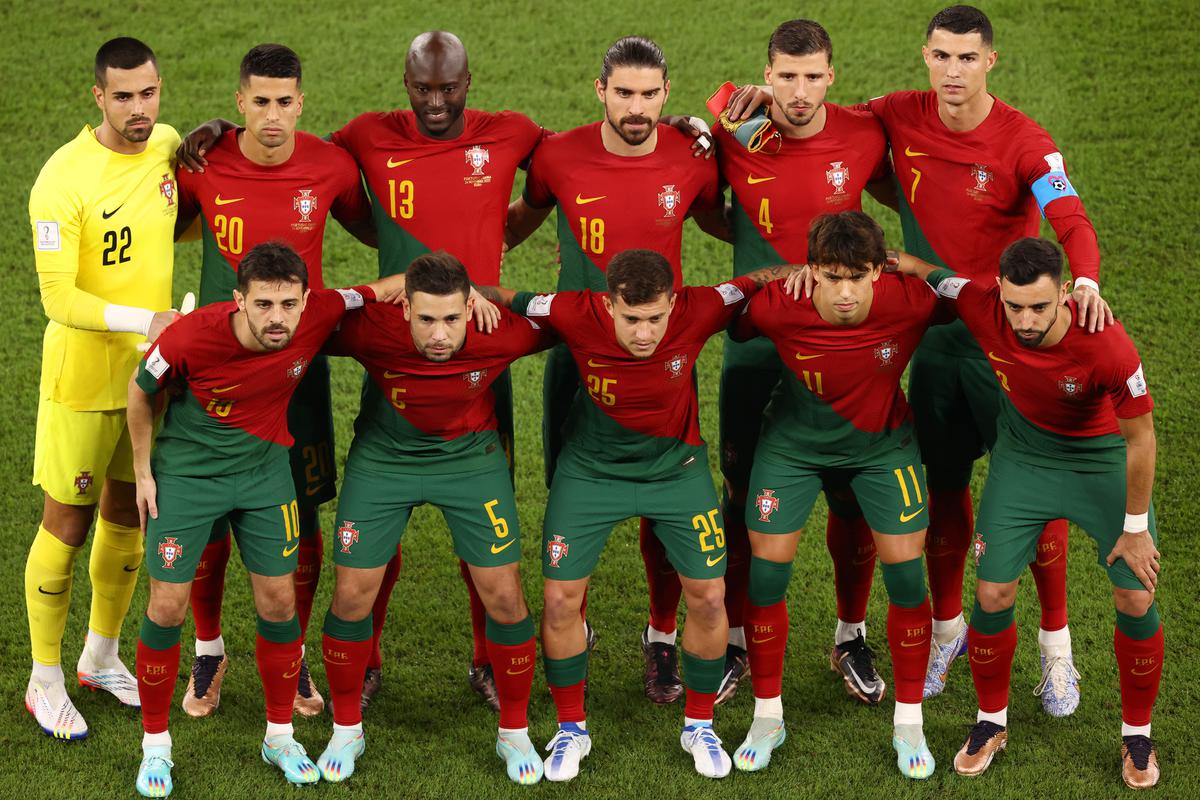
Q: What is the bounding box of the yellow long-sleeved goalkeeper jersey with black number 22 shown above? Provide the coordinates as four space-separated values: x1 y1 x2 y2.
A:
29 125 179 411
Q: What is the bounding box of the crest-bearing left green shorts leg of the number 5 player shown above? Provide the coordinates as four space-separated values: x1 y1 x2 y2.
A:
334 465 421 570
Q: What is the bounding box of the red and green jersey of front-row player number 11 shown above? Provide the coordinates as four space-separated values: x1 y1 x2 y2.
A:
733 272 950 467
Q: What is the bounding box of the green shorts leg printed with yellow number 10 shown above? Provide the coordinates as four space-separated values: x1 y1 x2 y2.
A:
229 459 300 578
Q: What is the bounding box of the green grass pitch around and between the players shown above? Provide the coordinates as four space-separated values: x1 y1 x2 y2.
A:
0 0 1200 800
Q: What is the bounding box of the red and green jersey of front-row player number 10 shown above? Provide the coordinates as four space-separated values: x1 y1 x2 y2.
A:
137 287 374 477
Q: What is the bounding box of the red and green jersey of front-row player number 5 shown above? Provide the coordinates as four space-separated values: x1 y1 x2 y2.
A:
326 305 557 474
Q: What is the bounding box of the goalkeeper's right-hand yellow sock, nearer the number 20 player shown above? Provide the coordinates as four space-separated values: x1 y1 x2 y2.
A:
88 517 145 639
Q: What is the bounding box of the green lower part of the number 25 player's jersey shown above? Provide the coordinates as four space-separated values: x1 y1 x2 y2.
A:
558 392 708 481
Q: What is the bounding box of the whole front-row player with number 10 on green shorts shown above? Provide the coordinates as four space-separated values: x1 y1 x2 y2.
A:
128 242 402 798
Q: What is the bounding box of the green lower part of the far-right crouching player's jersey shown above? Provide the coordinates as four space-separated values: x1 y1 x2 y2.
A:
996 393 1126 473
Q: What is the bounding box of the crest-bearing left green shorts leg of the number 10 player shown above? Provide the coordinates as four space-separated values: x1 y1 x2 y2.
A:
145 474 235 583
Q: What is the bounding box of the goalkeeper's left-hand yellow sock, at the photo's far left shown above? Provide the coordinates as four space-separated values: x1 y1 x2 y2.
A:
25 525 82 666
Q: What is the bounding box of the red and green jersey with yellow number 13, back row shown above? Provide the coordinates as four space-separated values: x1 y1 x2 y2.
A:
332 108 545 285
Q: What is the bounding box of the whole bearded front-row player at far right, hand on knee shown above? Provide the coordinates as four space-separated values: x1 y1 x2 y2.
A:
904 237 1163 789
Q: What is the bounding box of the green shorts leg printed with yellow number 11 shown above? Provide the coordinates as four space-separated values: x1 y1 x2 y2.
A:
850 440 929 534
